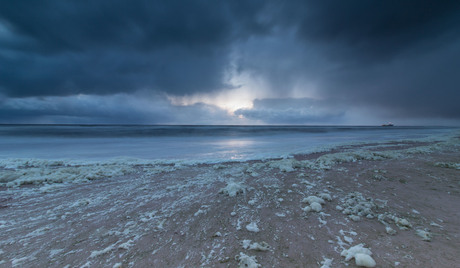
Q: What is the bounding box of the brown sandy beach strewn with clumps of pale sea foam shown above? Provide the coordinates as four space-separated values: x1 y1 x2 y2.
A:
0 138 460 267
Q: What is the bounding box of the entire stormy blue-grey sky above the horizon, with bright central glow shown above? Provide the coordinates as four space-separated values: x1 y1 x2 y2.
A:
0 0 460 125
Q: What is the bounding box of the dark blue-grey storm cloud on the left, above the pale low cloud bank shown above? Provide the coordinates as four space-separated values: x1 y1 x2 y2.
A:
0 0 266 97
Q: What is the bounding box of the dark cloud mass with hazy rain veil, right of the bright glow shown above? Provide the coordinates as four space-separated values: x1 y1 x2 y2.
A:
237 0 460 119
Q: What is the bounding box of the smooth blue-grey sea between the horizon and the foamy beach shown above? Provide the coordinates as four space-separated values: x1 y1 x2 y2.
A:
0 125 457 161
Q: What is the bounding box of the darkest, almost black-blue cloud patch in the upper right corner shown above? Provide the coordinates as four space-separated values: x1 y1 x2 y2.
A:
288 0 460 61
